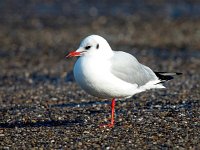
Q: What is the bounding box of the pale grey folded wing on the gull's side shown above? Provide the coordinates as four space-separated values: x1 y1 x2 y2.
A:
111 51 158 86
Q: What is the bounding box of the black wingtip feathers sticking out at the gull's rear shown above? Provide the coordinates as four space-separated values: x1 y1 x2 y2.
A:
154 72 182 83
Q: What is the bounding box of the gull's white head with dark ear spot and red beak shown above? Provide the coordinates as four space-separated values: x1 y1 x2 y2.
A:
66 35 112 58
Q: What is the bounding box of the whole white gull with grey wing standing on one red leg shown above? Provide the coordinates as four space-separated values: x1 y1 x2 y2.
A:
66 35 181 127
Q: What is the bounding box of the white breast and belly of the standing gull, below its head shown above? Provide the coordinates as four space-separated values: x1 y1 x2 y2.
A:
74 57 138 98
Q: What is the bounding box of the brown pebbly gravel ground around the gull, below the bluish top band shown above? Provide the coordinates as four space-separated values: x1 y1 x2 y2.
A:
0 0 200 149
